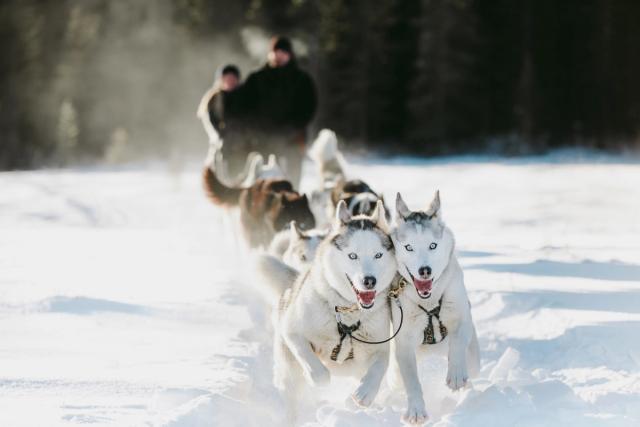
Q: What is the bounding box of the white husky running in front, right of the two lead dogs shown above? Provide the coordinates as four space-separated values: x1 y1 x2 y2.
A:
391 192 480 424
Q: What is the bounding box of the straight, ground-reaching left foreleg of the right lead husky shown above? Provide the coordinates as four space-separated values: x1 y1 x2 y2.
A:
395 337 429 425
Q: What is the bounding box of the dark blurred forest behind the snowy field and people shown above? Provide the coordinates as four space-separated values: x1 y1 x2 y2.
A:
0 0 640 169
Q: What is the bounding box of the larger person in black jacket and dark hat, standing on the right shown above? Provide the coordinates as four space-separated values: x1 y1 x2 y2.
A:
234 37 317 186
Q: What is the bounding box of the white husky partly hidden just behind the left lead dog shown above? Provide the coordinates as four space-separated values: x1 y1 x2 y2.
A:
269 221 328 271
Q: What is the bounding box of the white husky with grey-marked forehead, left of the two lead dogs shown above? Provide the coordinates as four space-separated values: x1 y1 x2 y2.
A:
274 202 397 414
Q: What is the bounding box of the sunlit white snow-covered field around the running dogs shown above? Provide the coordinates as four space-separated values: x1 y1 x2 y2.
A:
0 154 640 427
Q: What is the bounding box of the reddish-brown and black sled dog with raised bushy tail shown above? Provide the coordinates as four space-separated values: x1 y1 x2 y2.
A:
203 167 315 248
